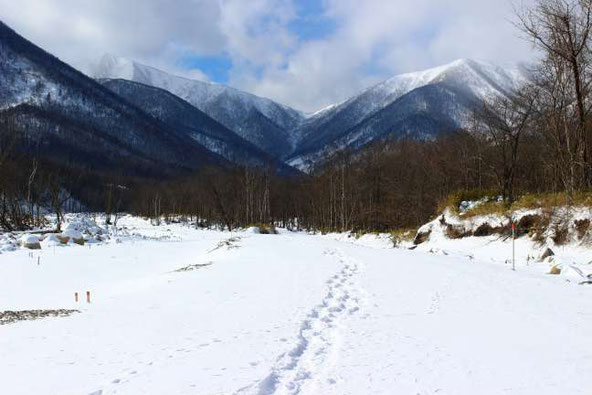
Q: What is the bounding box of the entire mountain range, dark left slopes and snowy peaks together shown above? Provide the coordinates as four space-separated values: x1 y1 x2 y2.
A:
0 17 526 173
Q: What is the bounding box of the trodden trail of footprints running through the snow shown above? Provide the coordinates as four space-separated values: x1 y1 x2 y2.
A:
237 250 361 395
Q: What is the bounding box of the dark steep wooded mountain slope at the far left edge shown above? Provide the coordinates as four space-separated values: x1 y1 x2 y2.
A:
0 22 225 175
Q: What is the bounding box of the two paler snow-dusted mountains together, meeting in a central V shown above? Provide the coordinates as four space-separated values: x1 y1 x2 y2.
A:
93 55 527 170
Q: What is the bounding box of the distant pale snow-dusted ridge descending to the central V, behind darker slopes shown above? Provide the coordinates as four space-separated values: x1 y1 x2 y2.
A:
92 55 303 157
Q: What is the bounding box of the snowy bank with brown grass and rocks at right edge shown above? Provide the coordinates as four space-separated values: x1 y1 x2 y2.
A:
409 207 592 283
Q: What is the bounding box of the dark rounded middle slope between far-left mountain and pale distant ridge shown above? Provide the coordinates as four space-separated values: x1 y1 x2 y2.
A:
99 79 297 174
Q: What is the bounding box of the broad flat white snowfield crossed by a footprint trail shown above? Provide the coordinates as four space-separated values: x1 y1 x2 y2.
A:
0 217 592 395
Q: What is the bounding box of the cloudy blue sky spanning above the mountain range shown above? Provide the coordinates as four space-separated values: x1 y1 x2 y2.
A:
0 0 534 111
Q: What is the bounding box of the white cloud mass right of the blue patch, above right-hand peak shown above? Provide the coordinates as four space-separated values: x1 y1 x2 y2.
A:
233 0 532 111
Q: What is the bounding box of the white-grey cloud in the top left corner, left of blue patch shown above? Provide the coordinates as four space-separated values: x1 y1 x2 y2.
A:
0 0 226 77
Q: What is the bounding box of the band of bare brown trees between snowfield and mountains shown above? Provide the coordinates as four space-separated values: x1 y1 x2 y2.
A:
120 130 558 231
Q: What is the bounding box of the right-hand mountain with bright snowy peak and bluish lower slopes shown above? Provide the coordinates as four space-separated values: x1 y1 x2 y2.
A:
288 59 525 168
